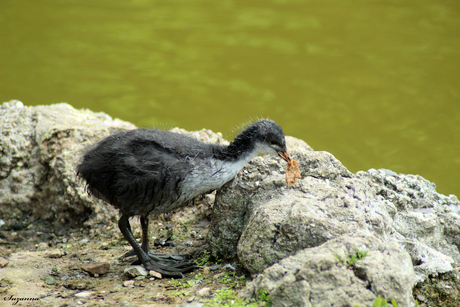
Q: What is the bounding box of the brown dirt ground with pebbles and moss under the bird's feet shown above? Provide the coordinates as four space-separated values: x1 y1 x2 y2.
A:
0 197 255 306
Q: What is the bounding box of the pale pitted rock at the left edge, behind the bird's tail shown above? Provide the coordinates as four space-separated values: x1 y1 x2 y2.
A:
0 101 135 227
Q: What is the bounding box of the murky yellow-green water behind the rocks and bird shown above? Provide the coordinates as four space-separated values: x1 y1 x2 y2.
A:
0 0 460 196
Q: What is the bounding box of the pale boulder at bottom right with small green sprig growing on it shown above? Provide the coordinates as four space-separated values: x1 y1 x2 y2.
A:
246 234 414 307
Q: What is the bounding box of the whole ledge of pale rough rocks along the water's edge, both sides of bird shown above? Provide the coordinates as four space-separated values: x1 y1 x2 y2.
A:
0 101 460 306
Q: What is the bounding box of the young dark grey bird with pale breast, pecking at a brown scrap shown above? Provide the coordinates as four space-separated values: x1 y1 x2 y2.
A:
76 119 289 278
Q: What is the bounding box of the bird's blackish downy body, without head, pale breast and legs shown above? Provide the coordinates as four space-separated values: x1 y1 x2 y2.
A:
77 129 219 216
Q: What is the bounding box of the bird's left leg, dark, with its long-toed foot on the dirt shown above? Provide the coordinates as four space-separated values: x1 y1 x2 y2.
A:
118 214 198 278
